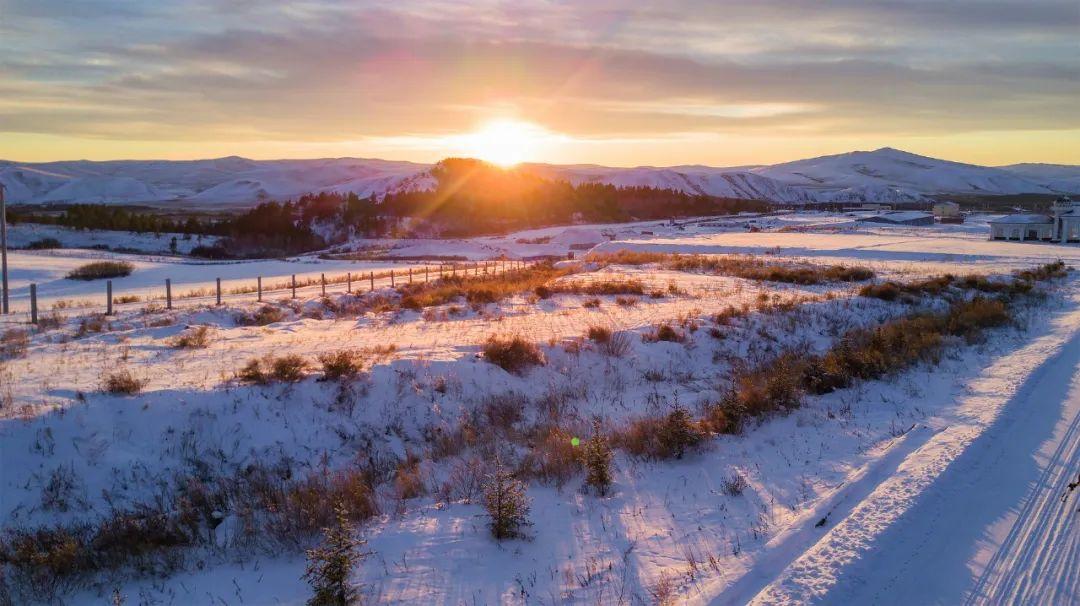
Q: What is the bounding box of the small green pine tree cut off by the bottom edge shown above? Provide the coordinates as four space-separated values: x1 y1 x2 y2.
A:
303 506 366 606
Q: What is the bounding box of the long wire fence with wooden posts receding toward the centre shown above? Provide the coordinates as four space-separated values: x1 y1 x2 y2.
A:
3 259 535 324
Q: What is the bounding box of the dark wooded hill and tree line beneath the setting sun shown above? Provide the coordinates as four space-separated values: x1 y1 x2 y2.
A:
8 158 768 257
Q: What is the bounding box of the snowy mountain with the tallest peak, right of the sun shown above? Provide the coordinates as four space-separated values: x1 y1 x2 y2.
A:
754 147 1054 194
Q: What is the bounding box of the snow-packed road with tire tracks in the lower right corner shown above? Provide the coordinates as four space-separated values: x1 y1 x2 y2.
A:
734 285 1080 604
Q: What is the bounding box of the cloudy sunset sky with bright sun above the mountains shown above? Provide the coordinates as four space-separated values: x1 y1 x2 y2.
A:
0 0 1080 166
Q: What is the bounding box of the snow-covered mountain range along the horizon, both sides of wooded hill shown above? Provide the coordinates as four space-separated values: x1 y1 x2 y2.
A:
0 148 1080 206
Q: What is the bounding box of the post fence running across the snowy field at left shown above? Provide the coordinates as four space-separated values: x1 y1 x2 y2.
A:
8 260 532 324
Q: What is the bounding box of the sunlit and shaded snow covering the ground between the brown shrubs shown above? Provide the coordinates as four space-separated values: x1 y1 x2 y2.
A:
0 214 1080 604
